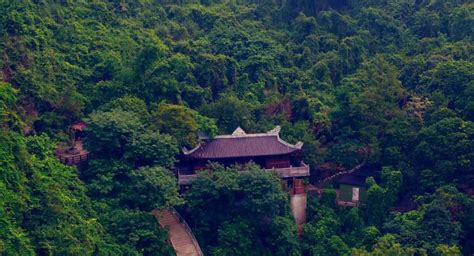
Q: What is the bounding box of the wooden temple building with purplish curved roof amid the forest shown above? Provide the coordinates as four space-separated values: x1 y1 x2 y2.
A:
177 126 310 194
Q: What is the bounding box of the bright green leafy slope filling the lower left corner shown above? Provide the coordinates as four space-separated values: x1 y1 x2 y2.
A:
0 132 112 255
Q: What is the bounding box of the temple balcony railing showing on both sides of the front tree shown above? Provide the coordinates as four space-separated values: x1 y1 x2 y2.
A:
178 162 310 185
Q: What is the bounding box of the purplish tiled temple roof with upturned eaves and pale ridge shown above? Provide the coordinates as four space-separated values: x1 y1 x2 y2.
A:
183 126 303 159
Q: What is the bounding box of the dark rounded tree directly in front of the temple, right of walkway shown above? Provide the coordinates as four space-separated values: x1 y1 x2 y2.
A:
185 165 297 255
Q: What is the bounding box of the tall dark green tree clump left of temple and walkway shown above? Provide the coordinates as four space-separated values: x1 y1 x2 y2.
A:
83 104 183 255
